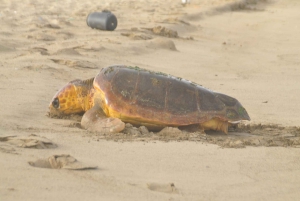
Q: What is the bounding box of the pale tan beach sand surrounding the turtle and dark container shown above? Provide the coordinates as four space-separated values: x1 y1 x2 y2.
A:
0 0 300 200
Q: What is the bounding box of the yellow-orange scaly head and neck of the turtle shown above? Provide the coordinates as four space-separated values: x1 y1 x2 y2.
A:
49 79 93 117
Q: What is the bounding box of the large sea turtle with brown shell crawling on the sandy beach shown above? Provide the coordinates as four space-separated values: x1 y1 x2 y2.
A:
49 65 250 133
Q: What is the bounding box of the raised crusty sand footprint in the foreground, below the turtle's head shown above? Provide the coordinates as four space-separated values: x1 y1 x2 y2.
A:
28 154 97 170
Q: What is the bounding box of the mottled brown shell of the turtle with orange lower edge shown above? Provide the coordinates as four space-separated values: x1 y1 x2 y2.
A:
94 66 250 128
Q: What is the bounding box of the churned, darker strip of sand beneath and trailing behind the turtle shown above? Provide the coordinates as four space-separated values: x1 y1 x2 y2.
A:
82 121 300 148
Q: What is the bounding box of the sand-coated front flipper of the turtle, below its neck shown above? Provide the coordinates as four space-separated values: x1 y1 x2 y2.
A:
81 106 125 133
